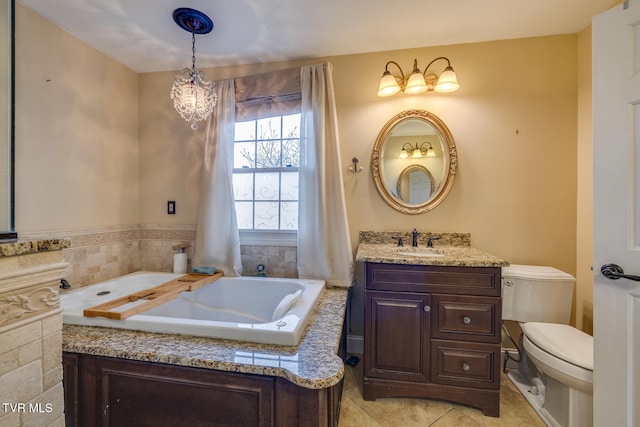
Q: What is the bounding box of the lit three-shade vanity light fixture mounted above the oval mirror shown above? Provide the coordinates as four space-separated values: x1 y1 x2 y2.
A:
378 56 460 97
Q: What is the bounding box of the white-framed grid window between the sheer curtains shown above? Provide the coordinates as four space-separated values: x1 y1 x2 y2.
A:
233 113 300 233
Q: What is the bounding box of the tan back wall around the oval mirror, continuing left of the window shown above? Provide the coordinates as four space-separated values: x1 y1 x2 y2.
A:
140 35 578 274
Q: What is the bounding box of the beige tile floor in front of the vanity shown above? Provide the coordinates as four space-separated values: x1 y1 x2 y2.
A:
339 359 545 427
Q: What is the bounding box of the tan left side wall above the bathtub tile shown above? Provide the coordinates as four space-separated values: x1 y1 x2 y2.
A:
15 3 138 234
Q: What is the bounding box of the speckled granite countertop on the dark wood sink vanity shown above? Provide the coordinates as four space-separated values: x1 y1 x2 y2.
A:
356 243 509 267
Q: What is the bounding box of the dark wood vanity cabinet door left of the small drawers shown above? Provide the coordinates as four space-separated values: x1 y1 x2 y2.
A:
364 291 430 382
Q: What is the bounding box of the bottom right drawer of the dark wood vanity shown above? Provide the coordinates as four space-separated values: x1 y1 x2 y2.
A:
431 340 500 389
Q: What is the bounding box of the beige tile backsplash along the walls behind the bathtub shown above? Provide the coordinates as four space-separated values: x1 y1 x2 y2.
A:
26 224 298 289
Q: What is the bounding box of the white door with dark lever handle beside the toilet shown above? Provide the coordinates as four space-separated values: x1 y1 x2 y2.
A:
593 0 640 426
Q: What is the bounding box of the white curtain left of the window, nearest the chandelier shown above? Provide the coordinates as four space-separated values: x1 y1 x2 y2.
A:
193 80 242 276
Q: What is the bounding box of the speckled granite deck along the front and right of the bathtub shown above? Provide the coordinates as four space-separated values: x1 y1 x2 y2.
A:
62 287 348 389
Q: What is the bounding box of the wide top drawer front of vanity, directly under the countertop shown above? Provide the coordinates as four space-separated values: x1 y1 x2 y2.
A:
366 262 501 296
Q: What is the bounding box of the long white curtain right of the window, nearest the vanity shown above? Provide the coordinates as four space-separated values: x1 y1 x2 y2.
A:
298 63 353 287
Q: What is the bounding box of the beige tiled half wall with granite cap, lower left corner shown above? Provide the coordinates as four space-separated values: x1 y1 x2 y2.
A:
0 241 69 427
